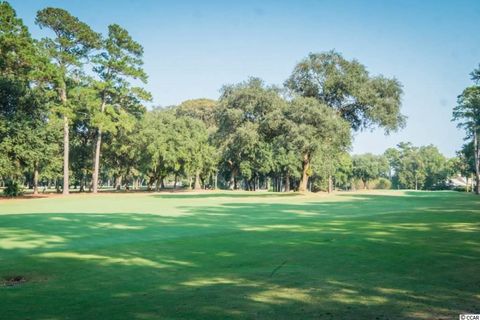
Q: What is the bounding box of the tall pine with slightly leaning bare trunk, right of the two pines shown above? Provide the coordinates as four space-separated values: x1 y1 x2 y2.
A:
91 24 151 192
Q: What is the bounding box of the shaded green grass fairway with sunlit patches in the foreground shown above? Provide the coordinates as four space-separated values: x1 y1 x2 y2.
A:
0 192 480 320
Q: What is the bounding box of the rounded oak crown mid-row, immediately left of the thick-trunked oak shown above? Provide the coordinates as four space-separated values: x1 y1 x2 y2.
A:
215 78 284 187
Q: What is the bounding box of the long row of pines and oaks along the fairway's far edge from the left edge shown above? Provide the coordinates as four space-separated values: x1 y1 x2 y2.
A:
0 2 470 194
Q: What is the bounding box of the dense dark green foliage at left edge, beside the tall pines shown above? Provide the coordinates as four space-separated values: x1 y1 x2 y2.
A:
0 2 62 185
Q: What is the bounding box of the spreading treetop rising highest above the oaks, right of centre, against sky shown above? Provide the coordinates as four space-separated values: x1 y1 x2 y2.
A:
285 51 405 133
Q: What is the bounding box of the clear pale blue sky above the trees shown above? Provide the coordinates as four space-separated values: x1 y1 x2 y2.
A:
10 0 480 156
